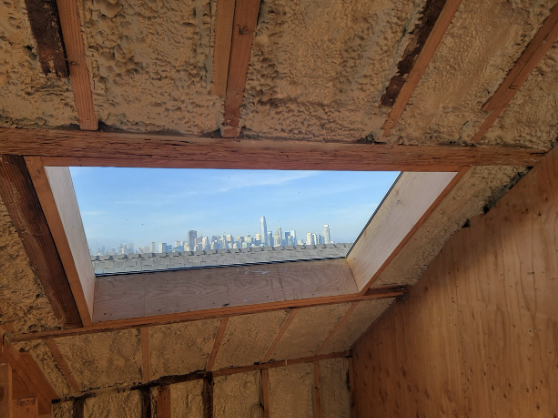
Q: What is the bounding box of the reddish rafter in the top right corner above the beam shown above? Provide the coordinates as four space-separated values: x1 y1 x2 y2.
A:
471 4 558 142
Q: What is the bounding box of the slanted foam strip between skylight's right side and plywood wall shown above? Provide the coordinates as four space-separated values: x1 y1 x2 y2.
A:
372 167 523 287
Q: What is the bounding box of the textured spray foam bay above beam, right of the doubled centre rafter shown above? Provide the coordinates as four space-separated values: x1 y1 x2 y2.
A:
241 0 424 141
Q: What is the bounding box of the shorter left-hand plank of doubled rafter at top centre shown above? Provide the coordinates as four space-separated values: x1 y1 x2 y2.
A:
213 0 236 96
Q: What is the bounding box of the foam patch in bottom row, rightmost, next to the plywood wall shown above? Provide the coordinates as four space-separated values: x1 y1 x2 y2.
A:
320 358 351 418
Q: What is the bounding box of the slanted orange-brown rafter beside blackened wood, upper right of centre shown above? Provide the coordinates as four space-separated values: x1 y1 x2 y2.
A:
382 0 461 136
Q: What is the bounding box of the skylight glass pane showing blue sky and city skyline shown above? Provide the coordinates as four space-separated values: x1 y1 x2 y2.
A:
70 167 399 275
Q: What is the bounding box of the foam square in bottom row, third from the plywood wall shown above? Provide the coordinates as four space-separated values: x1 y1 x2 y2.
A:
213 371 264 418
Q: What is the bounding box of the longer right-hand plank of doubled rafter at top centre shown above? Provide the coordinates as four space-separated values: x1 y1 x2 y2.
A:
221 0 260 137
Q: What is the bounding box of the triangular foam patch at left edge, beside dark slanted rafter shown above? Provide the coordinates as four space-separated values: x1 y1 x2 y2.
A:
0 198 61 333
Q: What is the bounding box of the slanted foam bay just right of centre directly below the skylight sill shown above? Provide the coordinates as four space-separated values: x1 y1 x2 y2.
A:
214 310 287 369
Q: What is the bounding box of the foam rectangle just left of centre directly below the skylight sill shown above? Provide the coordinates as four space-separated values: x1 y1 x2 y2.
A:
149 319 219 379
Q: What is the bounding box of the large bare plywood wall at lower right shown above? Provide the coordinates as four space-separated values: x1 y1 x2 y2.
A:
354 145 558 418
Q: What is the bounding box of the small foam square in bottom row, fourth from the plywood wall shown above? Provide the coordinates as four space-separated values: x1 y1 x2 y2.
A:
169 379 204 418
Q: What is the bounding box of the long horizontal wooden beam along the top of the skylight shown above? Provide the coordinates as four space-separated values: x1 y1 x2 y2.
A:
0 128 546 171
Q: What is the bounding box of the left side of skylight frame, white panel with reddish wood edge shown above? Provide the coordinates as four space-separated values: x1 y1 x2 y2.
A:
25 157 95 326
